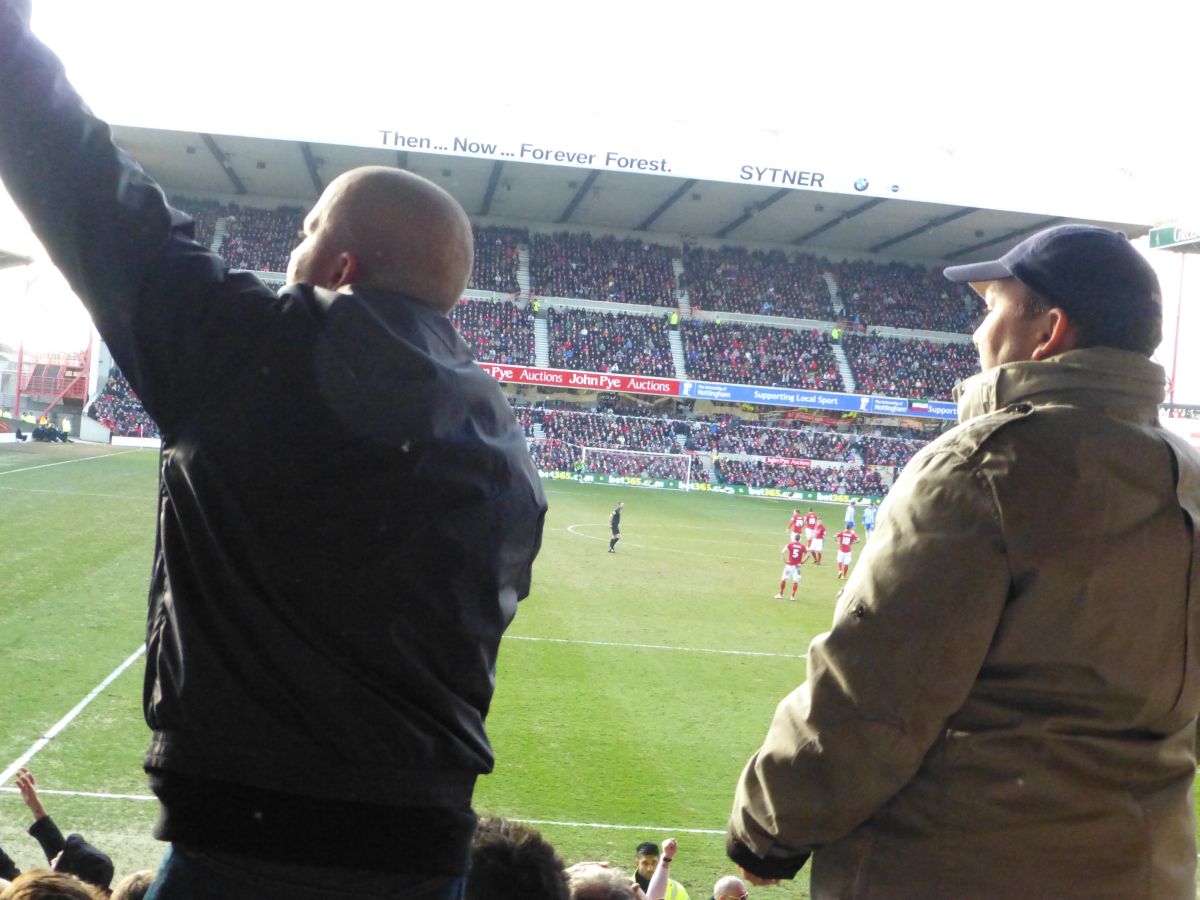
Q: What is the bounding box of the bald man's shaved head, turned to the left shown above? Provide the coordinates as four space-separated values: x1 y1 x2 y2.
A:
288 166 474 312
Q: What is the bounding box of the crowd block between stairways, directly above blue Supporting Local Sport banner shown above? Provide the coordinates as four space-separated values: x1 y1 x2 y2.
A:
680 319 845 391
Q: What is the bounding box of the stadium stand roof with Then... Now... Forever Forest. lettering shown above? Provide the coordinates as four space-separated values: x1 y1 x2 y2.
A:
113 126 1147 264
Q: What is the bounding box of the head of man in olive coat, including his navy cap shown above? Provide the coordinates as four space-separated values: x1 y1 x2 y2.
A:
946 226 1163 372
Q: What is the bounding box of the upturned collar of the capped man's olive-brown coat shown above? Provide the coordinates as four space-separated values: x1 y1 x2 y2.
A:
954 347 1166 422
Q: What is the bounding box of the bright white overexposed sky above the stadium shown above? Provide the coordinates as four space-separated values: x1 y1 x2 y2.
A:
0 0 1200 402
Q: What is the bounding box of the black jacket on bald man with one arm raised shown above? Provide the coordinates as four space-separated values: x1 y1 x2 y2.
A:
0 2 546 806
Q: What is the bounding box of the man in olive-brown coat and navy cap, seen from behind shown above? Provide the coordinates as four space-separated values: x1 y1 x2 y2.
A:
727 226 1200 900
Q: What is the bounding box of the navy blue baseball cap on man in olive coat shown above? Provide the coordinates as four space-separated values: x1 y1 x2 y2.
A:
944 224 1163 356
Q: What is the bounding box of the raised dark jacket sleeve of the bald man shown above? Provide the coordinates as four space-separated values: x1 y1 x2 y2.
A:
0 0 278 428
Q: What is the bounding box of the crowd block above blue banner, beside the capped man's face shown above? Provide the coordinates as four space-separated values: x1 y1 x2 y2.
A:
841 334 979 400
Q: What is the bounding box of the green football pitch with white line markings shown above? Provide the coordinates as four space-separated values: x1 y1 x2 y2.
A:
0 443 1195 900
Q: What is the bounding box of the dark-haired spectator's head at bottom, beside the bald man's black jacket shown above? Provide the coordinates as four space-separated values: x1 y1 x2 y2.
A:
464 816 570 900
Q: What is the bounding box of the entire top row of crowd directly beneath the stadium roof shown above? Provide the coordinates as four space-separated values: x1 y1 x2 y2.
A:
164 198 980 334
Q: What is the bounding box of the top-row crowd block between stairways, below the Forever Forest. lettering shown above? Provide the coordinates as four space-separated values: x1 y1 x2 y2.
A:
529 233 676 306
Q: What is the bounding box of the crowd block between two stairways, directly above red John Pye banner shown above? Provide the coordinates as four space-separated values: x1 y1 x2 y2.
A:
546 307 676 378
